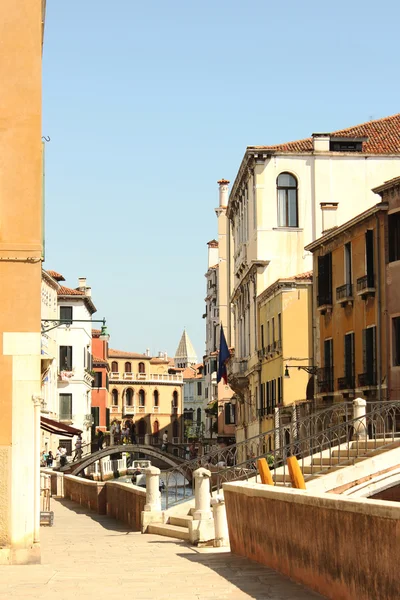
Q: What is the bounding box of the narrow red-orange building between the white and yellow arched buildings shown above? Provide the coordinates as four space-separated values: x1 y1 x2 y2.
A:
91 329 110 438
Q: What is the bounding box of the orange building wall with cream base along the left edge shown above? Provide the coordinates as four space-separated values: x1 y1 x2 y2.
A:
0 0 45 564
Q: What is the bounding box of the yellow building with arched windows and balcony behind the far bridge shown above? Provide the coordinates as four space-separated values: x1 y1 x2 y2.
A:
108 349 183 444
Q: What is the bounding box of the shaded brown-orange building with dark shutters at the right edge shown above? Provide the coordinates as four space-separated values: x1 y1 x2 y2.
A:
306 177 400 405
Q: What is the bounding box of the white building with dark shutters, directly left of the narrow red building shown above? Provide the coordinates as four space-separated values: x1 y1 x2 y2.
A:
56 276 96 454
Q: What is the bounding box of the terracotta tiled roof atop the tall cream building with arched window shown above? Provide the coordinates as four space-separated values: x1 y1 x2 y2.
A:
251 113 400 154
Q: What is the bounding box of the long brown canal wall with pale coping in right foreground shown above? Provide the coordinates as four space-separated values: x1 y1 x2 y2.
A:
223 482 400 600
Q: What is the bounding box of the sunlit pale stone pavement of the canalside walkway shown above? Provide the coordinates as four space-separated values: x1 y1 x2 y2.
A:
0 500 322 600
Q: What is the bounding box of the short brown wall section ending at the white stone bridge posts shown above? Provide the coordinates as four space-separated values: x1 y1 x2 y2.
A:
106 481 146 531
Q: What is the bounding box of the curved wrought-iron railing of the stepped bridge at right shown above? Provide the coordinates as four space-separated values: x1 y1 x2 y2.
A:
164 401 400 508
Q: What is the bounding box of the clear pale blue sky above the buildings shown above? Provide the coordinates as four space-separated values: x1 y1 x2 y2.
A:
43 0 400 358
